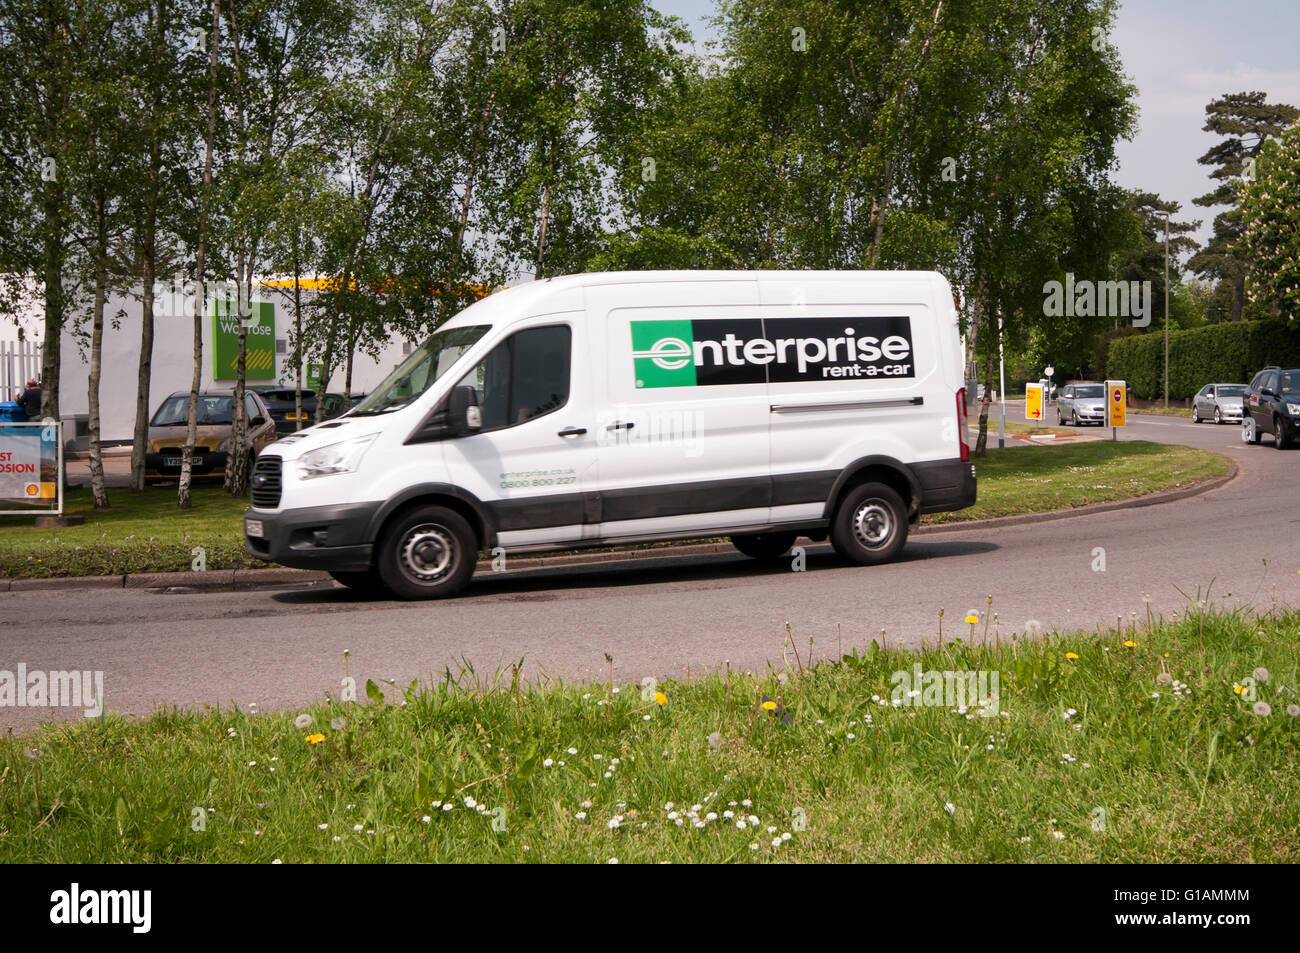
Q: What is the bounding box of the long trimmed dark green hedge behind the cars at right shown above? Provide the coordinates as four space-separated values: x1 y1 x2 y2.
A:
1106 315 1300 400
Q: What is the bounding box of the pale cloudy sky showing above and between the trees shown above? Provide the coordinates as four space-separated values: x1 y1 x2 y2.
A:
651 0 1300 256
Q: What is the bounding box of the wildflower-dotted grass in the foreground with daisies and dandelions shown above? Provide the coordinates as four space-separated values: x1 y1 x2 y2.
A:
0 606 1300 863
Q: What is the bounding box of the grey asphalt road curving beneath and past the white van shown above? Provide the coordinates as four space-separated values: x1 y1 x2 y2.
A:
0 411 1300 729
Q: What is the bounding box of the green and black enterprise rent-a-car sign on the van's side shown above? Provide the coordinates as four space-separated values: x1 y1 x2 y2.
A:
632 316 917 387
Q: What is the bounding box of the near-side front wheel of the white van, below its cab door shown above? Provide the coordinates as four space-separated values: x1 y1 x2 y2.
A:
377 506 478 599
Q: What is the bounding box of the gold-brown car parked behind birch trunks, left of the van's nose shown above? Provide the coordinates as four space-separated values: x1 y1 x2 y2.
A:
144 390 276 480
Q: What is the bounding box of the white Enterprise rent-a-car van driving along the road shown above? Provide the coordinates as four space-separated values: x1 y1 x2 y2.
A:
244 272 975 599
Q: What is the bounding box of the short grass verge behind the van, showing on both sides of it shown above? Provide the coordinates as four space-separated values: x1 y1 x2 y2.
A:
0 438 1229 577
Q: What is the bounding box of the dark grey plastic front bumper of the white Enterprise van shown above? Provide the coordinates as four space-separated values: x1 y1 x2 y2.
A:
244 502 382 572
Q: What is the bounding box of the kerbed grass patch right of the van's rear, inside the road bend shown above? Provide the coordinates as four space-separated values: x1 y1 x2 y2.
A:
923 439 1231 523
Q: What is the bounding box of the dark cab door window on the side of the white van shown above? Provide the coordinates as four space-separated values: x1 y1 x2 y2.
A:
460 325 572 430
